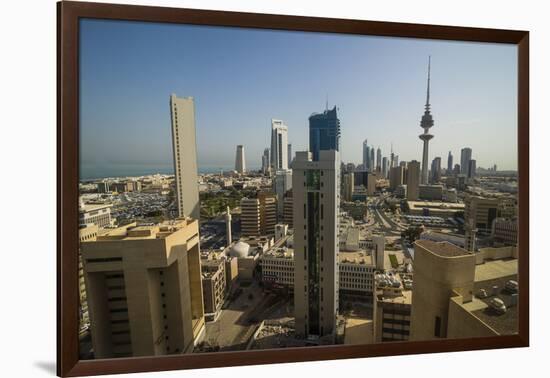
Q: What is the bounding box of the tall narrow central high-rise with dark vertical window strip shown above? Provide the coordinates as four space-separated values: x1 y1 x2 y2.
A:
292 150 340 339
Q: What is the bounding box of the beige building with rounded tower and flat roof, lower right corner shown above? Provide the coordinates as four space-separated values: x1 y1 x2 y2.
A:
410 240 519 341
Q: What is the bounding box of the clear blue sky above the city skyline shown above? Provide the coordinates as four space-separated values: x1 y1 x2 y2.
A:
80 20 517 178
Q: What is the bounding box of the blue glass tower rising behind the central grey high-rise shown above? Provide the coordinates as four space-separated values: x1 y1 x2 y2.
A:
309 106 340 164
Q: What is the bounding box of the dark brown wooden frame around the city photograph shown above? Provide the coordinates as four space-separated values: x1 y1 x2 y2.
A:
57 1 529 376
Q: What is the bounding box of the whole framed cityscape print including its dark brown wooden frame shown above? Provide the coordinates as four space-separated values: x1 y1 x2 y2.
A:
58 1 529 376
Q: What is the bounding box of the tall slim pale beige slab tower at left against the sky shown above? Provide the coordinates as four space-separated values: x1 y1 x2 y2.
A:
170 94 200 220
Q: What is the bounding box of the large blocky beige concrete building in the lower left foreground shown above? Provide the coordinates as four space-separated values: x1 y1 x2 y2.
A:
81 218 204 358
